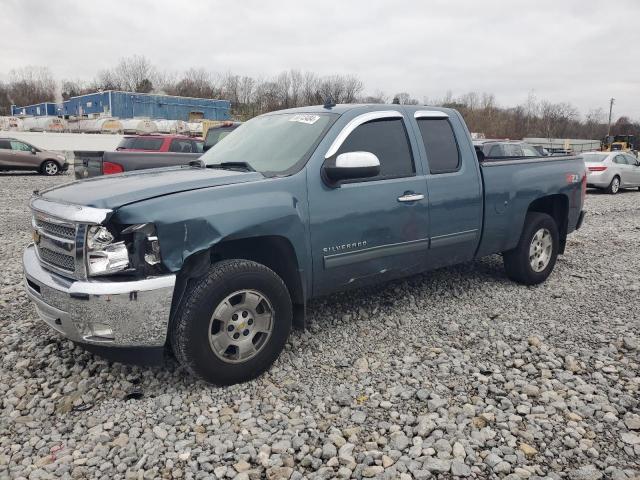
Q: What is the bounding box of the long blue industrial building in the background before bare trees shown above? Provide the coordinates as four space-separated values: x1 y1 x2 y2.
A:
11 90 231 121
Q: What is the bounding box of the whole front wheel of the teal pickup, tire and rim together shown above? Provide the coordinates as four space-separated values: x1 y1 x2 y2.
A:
171 259 293 385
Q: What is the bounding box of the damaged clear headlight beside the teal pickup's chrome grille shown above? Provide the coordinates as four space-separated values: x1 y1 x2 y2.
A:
86 225 129 276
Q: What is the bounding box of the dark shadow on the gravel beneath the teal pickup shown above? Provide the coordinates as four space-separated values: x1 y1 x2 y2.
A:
48 255 511 394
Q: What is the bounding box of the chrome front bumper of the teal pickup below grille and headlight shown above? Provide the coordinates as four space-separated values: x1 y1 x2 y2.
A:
22 245 176 347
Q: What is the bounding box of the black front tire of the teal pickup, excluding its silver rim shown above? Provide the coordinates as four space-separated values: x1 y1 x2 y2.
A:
170 259 293 385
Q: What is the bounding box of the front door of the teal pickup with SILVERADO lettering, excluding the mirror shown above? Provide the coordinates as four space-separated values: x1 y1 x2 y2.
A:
308 110 429 295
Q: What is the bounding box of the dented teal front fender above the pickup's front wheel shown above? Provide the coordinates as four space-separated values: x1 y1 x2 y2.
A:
114 172 310 282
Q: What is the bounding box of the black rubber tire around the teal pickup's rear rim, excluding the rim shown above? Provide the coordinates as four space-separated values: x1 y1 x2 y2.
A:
503 212 560 285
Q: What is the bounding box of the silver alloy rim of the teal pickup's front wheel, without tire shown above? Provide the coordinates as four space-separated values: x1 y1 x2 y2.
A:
208 290 275 363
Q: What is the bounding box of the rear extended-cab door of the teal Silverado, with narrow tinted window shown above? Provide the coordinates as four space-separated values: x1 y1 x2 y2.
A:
414 110 483 267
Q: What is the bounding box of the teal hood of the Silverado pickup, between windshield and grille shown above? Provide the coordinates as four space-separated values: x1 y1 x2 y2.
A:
42 166 264 209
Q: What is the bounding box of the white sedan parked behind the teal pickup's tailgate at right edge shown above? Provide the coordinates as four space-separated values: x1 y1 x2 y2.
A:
581 152 640 194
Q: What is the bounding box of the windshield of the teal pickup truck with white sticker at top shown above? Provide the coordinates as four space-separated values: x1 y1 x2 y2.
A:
200 113 337 175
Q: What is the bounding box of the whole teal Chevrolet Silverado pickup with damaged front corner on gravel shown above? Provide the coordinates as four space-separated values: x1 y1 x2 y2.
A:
23 104 586 384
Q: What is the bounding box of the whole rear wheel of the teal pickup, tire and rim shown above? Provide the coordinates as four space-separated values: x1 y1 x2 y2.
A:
503 212 559 285
